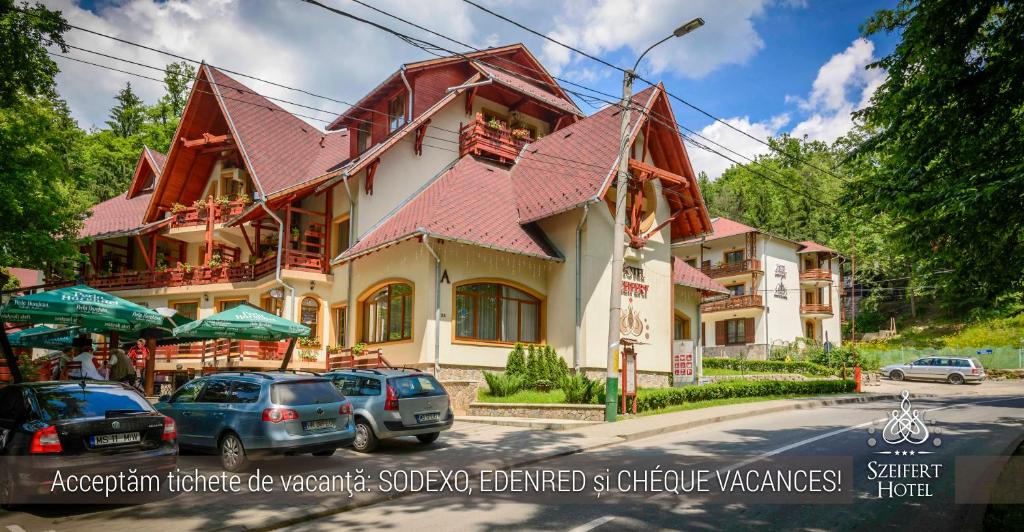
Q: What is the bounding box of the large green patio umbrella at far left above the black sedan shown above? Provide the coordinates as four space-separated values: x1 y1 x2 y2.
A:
0 284 164 333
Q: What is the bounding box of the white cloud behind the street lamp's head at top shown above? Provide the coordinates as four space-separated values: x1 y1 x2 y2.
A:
543 0 771 78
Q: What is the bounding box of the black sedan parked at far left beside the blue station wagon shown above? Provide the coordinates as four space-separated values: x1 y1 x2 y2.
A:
0 381 178 504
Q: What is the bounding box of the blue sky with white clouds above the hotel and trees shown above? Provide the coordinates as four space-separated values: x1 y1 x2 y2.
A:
44 0 896 177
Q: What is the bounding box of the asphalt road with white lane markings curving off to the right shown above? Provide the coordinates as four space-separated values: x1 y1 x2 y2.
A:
289 385 1024 532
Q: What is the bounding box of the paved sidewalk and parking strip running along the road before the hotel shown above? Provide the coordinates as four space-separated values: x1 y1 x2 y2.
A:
6 393 894 532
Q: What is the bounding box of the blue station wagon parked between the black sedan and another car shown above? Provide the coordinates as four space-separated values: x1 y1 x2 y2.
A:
157 371 355 472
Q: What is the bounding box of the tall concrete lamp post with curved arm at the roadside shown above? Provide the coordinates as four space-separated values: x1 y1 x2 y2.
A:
604 18 703 422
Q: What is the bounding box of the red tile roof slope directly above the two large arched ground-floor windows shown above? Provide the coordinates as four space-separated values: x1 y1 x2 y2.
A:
336 157 562 262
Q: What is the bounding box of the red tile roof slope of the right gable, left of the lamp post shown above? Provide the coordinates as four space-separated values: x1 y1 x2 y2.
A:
512 87 655 222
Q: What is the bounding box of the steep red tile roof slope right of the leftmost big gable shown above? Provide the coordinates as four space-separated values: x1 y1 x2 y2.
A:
204 65 349 195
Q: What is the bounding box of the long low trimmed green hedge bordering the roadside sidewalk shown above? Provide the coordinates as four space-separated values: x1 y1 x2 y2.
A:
637 381 856 412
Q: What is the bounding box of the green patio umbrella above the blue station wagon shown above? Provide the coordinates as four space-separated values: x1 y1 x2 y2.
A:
174 305 309 369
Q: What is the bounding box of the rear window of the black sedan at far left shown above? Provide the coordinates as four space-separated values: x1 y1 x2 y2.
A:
36 386 154 422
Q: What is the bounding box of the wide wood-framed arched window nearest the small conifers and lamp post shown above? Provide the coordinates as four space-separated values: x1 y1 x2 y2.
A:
455 282 541 343
